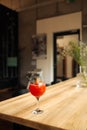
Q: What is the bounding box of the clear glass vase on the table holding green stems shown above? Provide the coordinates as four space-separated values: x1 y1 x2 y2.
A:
77 66 87 87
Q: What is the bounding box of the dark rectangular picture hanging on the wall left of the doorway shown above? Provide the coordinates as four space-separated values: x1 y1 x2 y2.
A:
32 33 47 59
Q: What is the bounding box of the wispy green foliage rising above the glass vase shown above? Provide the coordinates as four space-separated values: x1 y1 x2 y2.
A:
62 41 87 66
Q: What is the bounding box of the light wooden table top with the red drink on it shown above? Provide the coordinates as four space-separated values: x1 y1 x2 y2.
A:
0 78 87 130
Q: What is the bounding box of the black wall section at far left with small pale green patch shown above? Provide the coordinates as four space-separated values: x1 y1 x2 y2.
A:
0 5 18 88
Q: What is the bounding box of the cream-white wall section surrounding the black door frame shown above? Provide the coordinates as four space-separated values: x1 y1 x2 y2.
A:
37 12 82 83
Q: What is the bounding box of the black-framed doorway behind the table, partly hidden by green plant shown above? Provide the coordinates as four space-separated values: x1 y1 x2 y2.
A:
53 29 80 83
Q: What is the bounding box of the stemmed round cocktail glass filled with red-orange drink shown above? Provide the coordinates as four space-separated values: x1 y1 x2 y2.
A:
28 70 46 114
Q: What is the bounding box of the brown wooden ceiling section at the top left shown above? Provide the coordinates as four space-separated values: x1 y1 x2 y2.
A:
0 0 68 12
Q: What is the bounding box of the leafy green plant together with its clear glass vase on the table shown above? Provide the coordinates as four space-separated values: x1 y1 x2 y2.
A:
62 41 87 86
